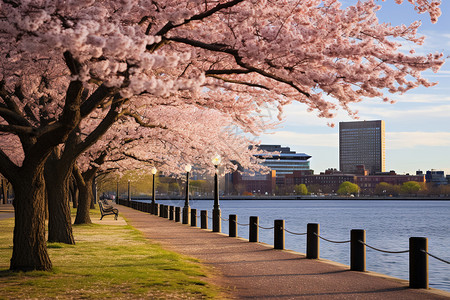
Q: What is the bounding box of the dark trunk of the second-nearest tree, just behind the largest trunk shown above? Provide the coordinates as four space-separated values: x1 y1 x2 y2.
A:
44 153 75 245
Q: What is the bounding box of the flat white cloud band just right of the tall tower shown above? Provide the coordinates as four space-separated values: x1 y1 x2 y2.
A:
386 131 450 150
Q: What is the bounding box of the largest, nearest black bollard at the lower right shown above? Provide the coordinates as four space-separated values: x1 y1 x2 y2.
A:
409 237 428 289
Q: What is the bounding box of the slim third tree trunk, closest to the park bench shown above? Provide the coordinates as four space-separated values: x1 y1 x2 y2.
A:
73 167 94 224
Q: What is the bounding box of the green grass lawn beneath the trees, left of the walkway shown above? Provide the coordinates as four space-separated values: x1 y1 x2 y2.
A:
0 210 219 299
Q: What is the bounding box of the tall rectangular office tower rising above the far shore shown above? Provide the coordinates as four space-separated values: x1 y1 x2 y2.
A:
339 120 386 174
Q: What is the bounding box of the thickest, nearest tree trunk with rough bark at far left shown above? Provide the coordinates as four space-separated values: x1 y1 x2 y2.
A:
10 167 52 271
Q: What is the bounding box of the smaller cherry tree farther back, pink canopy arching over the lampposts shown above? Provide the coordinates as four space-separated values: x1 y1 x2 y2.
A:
74 106 266 224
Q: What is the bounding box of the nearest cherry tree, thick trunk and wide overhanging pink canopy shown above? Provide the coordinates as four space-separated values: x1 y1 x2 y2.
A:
0 0 443 270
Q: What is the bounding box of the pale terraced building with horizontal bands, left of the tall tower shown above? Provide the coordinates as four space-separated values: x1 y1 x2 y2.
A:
253 145 312 177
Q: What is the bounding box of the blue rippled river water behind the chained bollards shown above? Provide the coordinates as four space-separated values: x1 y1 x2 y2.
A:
141 200 450 291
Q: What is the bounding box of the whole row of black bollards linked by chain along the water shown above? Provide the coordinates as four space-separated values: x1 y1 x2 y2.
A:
124 201 428 288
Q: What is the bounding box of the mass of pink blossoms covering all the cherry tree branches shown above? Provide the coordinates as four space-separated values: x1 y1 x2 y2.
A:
0 0 444 170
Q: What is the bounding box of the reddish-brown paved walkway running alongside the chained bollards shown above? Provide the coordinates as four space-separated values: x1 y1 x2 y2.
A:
118 206 450 300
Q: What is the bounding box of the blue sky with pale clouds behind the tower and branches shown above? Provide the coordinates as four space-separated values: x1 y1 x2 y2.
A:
260 0 450 174
